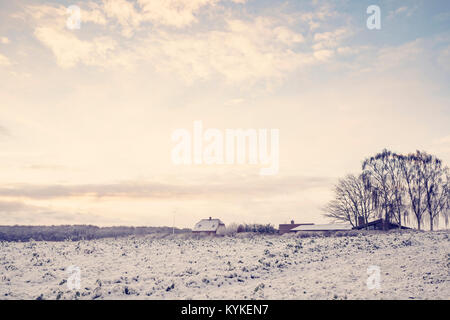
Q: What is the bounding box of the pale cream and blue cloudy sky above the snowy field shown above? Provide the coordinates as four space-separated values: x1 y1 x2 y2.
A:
0 0 450 227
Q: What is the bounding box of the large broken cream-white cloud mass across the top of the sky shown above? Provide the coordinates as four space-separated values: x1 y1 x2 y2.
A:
22 0 350 84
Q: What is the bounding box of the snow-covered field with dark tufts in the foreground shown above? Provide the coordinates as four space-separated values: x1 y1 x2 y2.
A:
0 231 450 299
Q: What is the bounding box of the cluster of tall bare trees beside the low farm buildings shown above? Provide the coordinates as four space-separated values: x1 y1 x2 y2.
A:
323 149 450 230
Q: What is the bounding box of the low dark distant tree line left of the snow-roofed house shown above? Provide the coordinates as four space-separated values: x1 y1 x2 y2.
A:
0 225 190 241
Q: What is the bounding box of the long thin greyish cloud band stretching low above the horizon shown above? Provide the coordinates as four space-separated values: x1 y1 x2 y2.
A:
0 176 333 200
